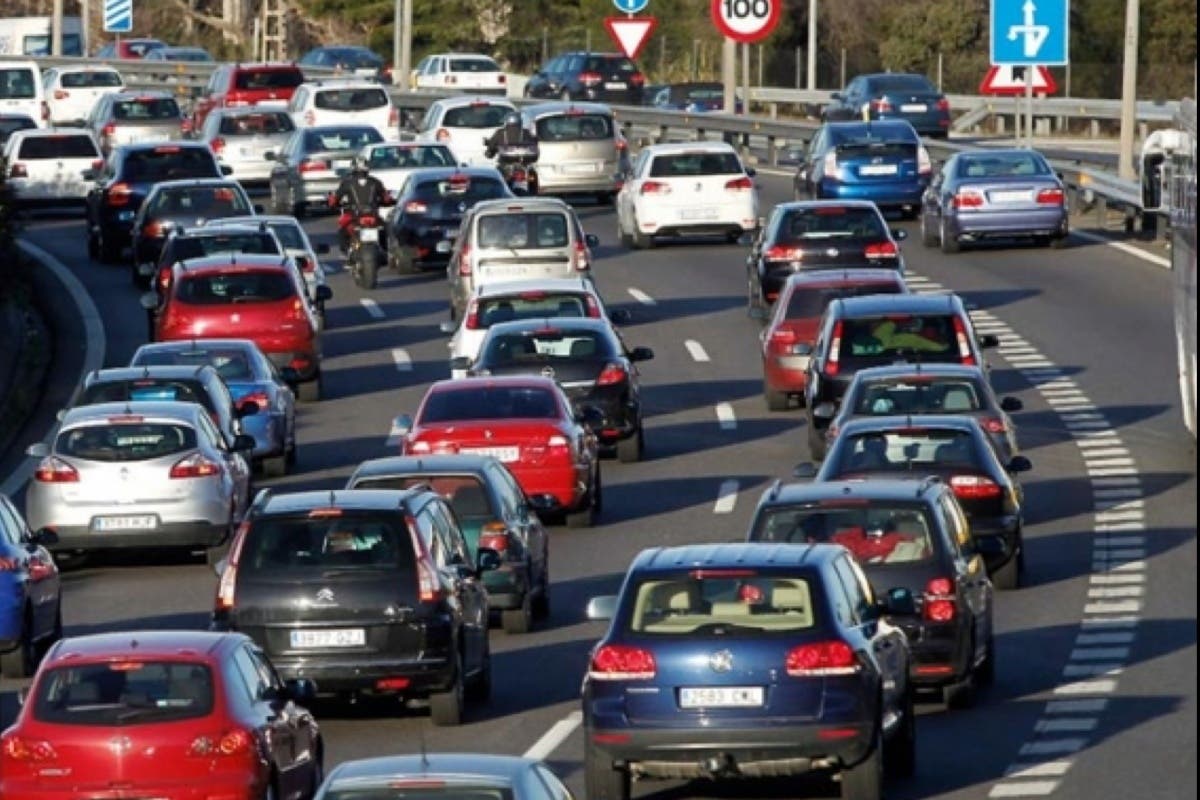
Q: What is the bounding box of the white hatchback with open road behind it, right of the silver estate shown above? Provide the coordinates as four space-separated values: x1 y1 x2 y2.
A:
617 142 758 247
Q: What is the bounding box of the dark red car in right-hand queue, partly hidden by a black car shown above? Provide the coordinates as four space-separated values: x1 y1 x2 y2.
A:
761 267 908 411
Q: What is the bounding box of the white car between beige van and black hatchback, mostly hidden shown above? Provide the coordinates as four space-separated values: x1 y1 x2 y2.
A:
442 278 629 378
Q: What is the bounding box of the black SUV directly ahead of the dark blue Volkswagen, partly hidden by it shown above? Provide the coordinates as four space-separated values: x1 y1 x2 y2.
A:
749 477 996 708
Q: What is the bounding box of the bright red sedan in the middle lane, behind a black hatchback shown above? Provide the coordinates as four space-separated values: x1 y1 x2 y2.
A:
395 375 602 528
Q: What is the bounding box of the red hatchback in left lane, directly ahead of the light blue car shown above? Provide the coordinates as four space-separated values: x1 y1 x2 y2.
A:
142 253 332 402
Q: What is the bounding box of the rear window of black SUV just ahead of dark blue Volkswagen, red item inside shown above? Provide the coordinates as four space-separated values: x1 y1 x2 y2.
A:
750 501 934 565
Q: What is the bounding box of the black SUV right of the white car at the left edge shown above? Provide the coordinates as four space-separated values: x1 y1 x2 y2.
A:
84 142 232 264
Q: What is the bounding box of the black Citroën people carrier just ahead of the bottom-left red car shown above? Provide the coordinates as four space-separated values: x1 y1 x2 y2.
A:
212 487 500 724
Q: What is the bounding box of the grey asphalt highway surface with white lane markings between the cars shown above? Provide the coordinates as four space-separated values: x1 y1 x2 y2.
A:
0 165 1196 800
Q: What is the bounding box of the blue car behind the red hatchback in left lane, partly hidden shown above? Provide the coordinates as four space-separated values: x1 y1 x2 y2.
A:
130 339 296 477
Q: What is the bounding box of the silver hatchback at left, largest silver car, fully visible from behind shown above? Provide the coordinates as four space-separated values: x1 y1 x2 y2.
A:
25 401 254 557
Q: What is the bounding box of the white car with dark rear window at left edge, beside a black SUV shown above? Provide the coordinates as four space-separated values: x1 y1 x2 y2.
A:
0 128 104 205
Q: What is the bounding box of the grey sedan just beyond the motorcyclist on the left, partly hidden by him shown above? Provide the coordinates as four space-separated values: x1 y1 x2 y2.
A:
264 125 383 217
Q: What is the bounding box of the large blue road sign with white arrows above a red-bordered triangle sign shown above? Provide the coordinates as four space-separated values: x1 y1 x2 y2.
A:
991 0 1070 66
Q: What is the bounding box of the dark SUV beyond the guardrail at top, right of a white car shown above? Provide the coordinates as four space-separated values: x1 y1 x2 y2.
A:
524 50 646 106
